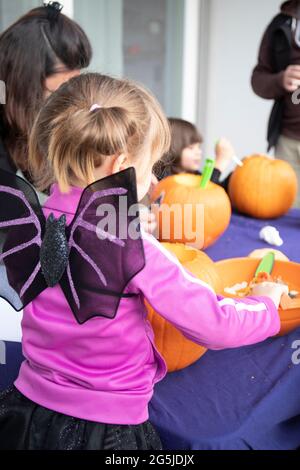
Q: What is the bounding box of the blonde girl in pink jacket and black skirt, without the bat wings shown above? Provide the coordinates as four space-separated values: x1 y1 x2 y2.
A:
0 74 284 450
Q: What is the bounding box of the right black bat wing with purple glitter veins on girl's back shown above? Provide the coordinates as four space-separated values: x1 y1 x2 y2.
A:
60 168 145 324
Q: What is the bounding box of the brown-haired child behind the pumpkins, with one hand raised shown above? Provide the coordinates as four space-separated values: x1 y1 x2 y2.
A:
155 118 235 189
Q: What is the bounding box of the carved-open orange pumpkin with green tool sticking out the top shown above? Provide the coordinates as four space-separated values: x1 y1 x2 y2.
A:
151 174 231 249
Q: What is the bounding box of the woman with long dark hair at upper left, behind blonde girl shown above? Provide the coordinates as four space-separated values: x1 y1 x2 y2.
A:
0 2 92 179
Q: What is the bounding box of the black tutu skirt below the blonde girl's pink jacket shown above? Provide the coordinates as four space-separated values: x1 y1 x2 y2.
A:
0 388 162 451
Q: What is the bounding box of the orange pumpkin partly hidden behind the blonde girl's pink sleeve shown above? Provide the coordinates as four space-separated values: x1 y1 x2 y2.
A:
146 243 222 372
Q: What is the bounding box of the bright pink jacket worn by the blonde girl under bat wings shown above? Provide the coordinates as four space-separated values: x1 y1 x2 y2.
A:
15 186 280 424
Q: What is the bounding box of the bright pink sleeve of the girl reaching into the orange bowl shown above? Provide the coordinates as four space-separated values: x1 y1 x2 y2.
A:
133 234 280 349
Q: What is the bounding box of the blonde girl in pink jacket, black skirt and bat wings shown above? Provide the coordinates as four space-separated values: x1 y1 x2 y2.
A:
0 74 287 451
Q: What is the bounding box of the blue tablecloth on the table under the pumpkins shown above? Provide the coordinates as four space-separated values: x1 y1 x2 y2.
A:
150 210 300 450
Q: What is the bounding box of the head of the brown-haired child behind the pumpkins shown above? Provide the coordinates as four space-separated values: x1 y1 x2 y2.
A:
158 118 203 178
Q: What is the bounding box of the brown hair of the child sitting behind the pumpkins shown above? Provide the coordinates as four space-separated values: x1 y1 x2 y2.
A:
154 118 203 179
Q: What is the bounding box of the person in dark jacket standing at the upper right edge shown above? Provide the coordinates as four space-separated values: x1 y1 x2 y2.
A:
252 0 300 207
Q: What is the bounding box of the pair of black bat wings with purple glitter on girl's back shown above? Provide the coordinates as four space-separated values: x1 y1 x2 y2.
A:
0 168 145 324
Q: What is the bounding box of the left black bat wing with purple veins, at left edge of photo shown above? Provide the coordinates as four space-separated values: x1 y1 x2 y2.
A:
0 170 47 311
